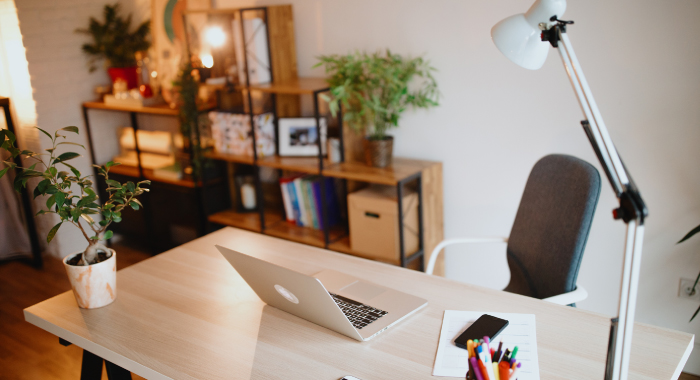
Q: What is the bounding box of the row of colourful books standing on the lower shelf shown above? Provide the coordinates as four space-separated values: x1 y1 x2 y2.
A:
280 175 340 230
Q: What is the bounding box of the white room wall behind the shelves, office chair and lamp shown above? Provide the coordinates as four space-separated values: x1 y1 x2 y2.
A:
17 0 700 373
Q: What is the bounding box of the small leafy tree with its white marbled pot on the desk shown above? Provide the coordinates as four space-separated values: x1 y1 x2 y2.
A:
0 127 150 309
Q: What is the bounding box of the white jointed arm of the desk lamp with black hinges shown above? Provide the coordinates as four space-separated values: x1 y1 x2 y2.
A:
542 23 648 380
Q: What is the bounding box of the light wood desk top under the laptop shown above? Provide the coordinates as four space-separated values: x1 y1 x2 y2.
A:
24 228 694 380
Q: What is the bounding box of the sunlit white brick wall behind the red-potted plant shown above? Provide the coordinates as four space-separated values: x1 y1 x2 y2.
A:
15 0 151 257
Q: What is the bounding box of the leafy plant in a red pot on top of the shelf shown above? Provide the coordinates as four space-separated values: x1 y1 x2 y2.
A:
76 3 151 89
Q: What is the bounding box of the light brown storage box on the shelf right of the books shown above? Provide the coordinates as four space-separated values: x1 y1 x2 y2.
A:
348 186 418 264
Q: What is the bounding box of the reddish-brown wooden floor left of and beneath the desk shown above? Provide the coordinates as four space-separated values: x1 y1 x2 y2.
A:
0 239 151 380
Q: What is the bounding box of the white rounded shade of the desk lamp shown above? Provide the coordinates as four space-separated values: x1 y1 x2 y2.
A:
491 0 566 70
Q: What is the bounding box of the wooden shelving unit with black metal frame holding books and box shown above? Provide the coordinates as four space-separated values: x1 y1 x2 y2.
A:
185 5 443 269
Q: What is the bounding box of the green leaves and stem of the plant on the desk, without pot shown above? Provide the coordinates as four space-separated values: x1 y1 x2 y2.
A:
0 127 151 265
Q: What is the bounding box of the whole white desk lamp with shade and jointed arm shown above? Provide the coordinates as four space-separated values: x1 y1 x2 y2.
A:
491 0 648 380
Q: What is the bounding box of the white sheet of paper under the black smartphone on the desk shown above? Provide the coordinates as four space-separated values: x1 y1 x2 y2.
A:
433 310 540 380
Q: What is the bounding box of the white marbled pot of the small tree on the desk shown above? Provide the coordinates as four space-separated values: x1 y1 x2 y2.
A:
63 249 117 309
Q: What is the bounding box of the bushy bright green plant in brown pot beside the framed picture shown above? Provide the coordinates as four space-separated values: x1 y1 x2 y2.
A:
314 49 439 167
